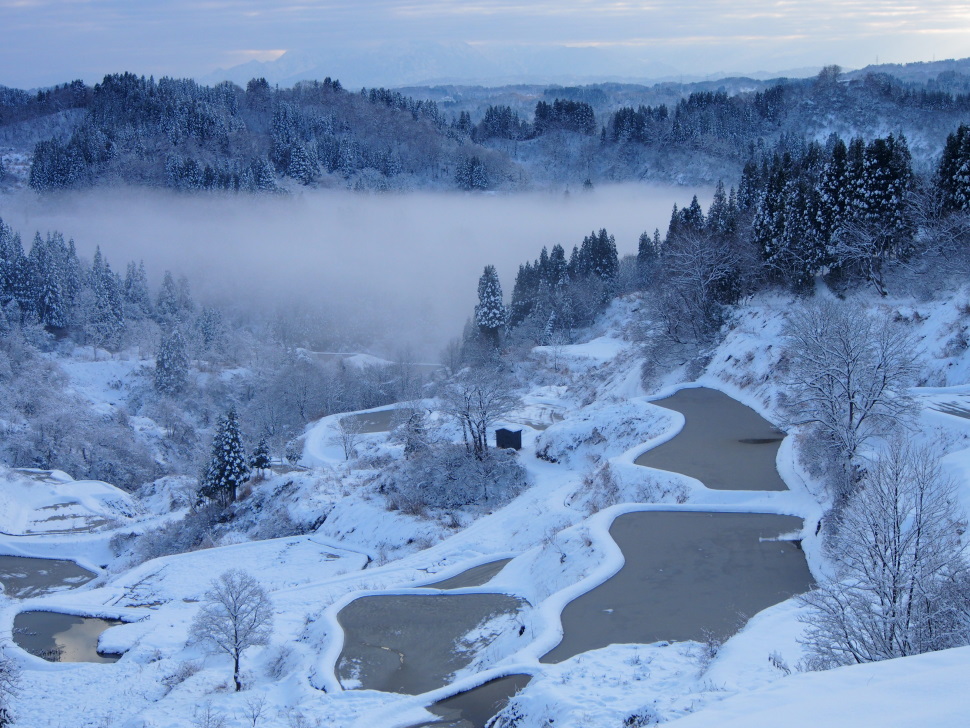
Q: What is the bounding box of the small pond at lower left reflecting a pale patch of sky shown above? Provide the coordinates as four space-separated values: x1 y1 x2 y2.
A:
13 612 124 662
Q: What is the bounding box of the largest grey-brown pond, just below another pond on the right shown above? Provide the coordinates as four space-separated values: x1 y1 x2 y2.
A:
542 511 812 663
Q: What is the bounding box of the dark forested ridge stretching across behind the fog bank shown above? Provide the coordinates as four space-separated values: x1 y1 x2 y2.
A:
0 67 970 192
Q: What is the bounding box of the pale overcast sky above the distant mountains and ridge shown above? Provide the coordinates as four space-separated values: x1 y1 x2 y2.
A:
0 0 970 88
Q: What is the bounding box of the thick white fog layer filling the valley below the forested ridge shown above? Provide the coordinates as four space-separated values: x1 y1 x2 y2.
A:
0 185 711 360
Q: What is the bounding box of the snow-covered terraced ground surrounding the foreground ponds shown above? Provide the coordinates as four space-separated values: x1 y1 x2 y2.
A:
0 298 970 728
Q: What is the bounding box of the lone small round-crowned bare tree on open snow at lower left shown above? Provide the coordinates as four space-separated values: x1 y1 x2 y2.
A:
191 569 273 691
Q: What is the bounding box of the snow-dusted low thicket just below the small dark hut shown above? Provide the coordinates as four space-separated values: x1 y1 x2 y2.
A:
379 444 527 513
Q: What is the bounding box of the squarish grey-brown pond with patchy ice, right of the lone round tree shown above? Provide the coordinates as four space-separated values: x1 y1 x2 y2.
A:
337 594 527 695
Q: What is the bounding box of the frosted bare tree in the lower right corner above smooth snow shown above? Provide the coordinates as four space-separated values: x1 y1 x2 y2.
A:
802 441 970 668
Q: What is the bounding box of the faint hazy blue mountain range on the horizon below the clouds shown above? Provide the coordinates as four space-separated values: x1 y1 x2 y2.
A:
197 41 818 89
